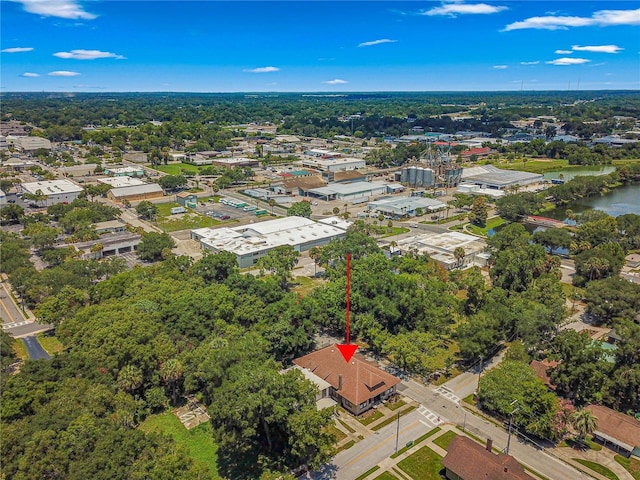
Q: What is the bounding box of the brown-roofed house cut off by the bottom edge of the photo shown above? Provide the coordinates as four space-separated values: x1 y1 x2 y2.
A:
442 436 534 480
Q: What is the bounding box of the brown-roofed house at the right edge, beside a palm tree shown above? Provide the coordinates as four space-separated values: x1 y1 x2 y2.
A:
586 405 640 458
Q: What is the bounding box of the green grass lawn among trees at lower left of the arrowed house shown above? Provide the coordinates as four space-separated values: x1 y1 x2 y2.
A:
140 412 220 479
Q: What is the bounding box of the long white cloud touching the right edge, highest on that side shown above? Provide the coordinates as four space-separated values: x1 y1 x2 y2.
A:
504 8 640 31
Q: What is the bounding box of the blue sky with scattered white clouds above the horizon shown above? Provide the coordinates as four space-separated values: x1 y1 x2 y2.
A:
0 0 640 92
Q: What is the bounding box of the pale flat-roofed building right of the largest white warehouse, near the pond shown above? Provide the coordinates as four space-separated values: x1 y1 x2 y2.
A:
397 232 487 270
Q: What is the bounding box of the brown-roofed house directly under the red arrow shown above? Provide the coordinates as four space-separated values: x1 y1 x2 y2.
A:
293 345 400 415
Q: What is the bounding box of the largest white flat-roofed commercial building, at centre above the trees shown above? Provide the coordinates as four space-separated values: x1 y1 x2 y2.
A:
191 217 346 268
